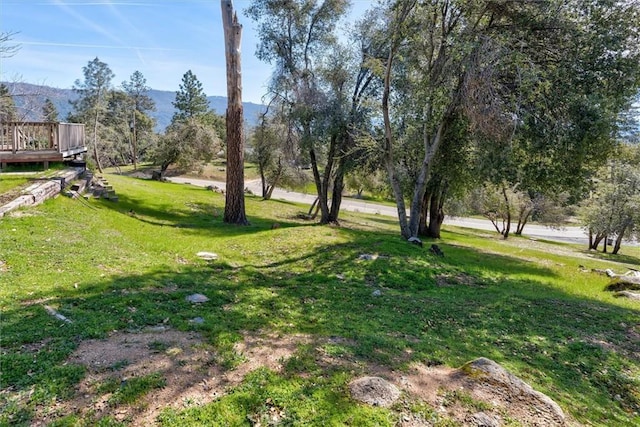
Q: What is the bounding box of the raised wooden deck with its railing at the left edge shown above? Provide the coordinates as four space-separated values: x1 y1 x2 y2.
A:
0 122 87 168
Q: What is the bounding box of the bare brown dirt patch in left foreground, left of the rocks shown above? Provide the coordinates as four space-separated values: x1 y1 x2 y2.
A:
32 328 308 426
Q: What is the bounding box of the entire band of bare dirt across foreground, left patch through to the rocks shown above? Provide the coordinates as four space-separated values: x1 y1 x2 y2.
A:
32 327 562 427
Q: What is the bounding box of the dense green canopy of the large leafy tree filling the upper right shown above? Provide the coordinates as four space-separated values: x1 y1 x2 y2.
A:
372 0 639 238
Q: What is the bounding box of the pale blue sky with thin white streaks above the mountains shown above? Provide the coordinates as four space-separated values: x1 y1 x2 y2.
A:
0 0 371 103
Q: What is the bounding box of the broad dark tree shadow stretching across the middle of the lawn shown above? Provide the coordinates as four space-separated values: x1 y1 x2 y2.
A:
1 224 640 425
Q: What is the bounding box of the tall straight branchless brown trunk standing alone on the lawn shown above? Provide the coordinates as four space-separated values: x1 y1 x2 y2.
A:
220 0 249 225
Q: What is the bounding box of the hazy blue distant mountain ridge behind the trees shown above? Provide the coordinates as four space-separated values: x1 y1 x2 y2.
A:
3 82 266 132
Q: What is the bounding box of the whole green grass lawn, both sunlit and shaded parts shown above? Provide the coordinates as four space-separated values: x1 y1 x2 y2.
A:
0 175 640 426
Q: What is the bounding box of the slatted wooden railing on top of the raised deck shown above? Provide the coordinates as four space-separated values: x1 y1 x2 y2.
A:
0 122 85 154
